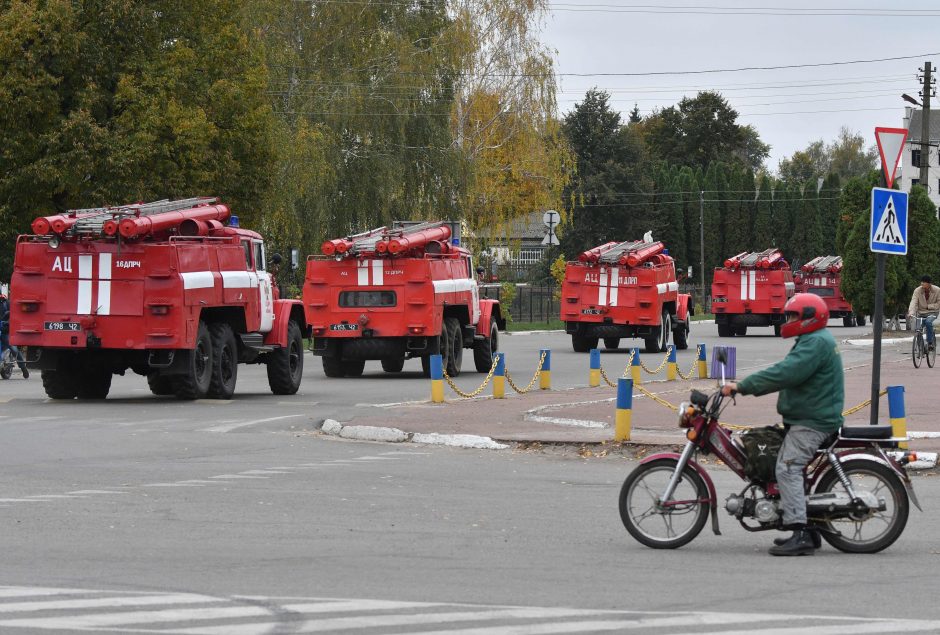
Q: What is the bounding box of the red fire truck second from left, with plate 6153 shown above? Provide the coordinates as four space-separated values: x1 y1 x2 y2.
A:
303 222 506 377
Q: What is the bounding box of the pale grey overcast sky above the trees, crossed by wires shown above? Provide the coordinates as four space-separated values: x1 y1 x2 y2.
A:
541 0 940 171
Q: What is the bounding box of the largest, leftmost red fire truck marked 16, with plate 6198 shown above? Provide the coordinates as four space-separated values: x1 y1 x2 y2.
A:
10 198 307 399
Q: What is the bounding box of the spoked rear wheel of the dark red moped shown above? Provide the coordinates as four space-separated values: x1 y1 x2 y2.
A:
815 459 910 553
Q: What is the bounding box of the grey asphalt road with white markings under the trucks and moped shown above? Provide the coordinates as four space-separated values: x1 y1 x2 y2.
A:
0 325 940 635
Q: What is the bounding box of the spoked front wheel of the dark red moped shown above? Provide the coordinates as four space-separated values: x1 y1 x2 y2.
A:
620 458 711 549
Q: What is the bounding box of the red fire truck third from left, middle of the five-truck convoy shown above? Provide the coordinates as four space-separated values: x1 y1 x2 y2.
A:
561 241 692 353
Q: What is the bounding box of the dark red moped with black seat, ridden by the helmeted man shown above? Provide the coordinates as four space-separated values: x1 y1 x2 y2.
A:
620 356 921 553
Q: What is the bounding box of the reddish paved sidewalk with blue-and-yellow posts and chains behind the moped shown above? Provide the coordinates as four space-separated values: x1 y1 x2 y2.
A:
343 355 940 452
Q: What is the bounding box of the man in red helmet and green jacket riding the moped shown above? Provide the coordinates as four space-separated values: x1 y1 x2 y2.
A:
721 293 845 556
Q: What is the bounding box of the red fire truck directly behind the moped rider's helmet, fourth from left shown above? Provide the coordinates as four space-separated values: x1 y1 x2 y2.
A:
712 249 795 337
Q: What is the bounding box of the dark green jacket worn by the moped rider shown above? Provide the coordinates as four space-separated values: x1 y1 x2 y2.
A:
738 329 845 432
